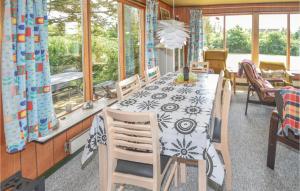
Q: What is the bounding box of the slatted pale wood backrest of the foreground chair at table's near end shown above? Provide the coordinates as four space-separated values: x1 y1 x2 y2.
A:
103 108 161 179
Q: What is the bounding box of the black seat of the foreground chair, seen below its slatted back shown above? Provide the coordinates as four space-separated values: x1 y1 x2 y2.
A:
115 155 171 178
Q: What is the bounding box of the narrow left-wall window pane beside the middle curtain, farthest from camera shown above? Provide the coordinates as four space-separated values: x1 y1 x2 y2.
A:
124 5 141 77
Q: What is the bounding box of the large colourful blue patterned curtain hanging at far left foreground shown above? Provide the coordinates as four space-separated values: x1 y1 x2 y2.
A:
1 0 57 153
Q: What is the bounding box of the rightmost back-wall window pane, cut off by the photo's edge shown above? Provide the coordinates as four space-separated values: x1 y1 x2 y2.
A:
290 14 300 72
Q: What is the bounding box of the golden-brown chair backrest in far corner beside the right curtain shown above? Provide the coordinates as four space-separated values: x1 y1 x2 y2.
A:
203 50 228 74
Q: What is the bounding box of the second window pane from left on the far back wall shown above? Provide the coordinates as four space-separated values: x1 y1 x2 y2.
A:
225 15 252 68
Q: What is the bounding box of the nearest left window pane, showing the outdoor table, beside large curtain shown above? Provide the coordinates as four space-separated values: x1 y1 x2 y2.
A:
48 0 84 114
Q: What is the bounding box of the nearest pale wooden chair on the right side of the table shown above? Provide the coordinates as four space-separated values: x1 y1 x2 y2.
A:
212 80 232 191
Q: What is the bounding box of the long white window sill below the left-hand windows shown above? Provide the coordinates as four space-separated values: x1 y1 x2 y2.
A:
35 98 117 143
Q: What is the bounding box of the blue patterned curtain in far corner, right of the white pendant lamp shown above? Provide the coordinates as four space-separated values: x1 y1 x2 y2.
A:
188 9 203 64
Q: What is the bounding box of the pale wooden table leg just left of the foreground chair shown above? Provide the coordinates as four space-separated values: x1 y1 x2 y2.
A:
98 144 107 191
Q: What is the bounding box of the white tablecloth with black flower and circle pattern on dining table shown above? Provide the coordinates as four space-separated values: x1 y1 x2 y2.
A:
82 73 224 185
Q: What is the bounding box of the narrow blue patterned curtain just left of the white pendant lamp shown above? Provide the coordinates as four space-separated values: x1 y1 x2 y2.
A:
146 0 158 68
